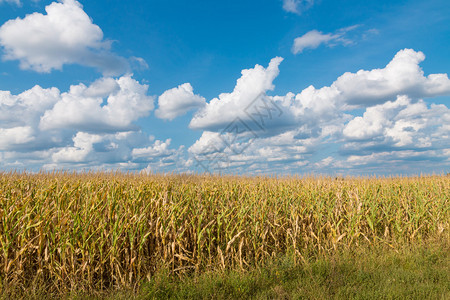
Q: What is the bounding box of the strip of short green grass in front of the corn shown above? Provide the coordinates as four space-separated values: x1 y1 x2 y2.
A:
136 246 450 299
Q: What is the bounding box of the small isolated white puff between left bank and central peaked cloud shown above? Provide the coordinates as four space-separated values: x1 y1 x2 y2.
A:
155 83 206 120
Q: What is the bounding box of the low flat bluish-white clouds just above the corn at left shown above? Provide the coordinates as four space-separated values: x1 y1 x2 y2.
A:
0 128 184 171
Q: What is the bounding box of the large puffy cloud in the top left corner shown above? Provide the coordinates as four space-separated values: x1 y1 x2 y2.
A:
0 0 129 75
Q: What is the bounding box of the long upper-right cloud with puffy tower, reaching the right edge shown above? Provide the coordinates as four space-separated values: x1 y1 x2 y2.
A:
297 49 450 108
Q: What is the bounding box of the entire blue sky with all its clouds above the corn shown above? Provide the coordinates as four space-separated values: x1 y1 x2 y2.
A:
0 0 450 175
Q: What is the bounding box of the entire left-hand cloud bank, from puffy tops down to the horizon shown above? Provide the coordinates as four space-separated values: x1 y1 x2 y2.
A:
0 76 183 171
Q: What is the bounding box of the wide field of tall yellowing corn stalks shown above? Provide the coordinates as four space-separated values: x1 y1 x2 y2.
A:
0 173 450 291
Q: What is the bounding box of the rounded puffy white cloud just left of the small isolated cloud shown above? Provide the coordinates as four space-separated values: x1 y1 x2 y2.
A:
39 76 154 132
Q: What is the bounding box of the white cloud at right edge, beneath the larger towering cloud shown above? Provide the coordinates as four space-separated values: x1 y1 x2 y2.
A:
343 96 450 150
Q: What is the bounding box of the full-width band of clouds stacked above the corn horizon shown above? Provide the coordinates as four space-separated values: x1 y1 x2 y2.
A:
0 49 450 173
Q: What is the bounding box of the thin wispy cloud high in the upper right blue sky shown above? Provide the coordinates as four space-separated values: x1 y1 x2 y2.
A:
292 25 359 54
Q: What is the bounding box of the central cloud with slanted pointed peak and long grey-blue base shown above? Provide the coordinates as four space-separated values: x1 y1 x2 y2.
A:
190 58 346 138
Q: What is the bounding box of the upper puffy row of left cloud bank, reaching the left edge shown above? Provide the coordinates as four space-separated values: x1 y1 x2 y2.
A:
0 75 154 140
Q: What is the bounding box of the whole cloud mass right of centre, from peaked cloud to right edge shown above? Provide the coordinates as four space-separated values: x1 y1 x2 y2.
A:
188 49 450 174
